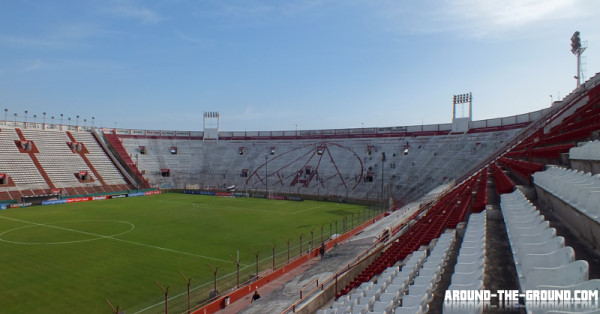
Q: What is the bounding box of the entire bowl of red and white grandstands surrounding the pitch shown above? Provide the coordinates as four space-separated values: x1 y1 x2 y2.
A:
0 74 600 313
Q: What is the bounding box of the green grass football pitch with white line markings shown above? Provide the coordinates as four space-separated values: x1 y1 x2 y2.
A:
0 194 375 313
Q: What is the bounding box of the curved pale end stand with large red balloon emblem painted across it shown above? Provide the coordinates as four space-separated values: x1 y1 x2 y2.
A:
115 111 543 203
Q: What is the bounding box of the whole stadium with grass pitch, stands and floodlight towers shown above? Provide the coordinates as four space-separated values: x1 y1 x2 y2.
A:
0 2 600 314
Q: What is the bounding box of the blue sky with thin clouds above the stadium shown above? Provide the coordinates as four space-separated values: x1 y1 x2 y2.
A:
0 0 600 131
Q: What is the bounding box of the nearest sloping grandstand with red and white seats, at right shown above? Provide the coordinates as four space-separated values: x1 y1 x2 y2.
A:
280 75 600 313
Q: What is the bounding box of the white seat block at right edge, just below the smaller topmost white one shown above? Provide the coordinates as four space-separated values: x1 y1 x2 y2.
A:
533 166 600 218
